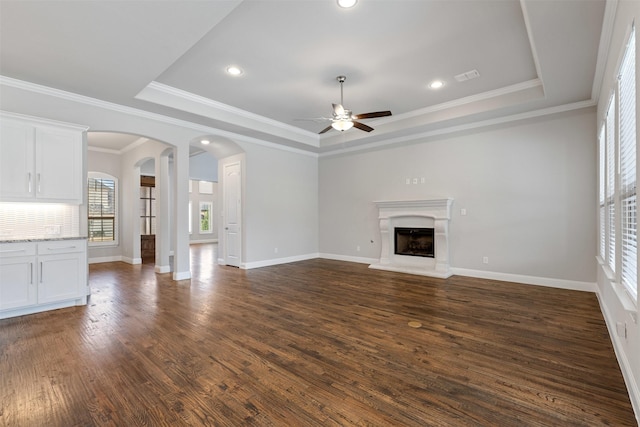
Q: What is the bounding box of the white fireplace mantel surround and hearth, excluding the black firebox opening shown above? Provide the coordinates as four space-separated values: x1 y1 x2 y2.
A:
369 198 453 278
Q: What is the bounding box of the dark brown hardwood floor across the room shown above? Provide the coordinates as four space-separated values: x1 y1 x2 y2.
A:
0 245 636 426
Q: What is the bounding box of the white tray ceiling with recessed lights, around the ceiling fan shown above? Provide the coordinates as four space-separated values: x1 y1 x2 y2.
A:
0 0 607 152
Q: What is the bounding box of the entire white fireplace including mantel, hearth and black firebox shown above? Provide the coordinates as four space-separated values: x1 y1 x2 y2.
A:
369 198 453 278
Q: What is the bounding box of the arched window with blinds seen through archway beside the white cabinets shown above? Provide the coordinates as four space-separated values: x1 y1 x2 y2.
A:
87 172 118 246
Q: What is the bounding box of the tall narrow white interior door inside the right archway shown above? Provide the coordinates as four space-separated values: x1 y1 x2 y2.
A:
223 162 242 267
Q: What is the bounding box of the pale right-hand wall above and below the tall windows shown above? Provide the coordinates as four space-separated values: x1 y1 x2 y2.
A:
593 0 640 424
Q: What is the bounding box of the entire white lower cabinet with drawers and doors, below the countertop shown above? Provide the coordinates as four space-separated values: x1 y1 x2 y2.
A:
0 240 87 319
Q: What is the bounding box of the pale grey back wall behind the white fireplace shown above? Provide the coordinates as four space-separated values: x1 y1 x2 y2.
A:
320 109 596 290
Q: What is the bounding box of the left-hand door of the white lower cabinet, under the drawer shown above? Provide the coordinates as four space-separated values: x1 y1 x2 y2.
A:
0 257 37 310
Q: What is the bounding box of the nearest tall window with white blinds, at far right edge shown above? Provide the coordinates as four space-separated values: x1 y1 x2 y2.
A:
618 30 638 300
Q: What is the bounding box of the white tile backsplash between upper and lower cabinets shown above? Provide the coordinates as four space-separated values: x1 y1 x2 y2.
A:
0 203 80 240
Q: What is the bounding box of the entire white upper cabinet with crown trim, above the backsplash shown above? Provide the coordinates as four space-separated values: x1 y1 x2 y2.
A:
0 113 86 204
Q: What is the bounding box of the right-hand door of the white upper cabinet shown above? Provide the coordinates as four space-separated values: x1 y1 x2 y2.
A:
35 127 83 203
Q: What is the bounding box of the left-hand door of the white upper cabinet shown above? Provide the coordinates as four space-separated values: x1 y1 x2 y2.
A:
0 119 35 200
